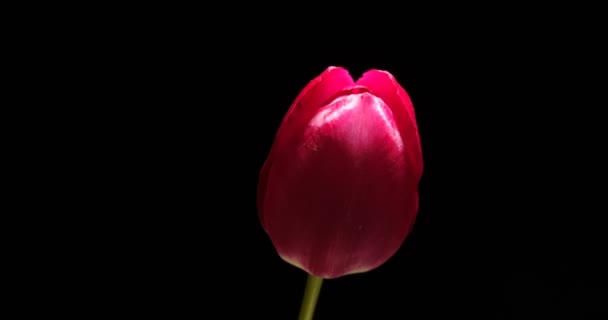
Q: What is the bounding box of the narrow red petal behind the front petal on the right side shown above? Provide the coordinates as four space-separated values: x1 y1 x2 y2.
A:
357 69 423 180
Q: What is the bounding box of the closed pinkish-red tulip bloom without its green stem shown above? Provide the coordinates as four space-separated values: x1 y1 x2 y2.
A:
257 67 423 279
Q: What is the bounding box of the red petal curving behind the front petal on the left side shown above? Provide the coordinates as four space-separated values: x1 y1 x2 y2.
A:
257 67 354 229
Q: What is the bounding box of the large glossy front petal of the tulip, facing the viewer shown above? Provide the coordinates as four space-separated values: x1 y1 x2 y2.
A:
261 92 418 279
